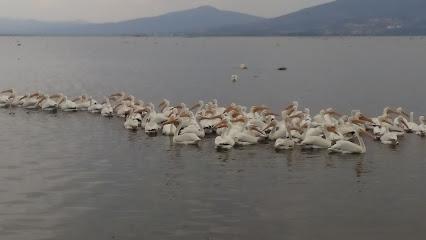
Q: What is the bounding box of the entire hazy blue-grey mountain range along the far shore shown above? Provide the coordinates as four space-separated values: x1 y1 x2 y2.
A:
0 0 426 36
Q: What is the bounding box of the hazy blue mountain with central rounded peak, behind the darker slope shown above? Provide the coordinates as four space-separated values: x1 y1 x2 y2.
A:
58 6 264 35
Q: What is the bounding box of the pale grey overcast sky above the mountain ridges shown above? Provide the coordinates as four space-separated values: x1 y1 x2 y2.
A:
0 0 332 22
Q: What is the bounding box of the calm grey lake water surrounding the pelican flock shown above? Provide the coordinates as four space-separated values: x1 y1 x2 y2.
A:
0 37 426 240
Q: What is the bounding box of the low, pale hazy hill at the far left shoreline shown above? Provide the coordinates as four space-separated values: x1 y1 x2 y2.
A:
0 18 89 35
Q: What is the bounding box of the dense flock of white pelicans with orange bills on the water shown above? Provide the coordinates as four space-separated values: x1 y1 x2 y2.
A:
0 89 426 154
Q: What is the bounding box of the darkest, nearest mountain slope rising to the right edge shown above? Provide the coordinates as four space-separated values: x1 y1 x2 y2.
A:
203 0 426 35
